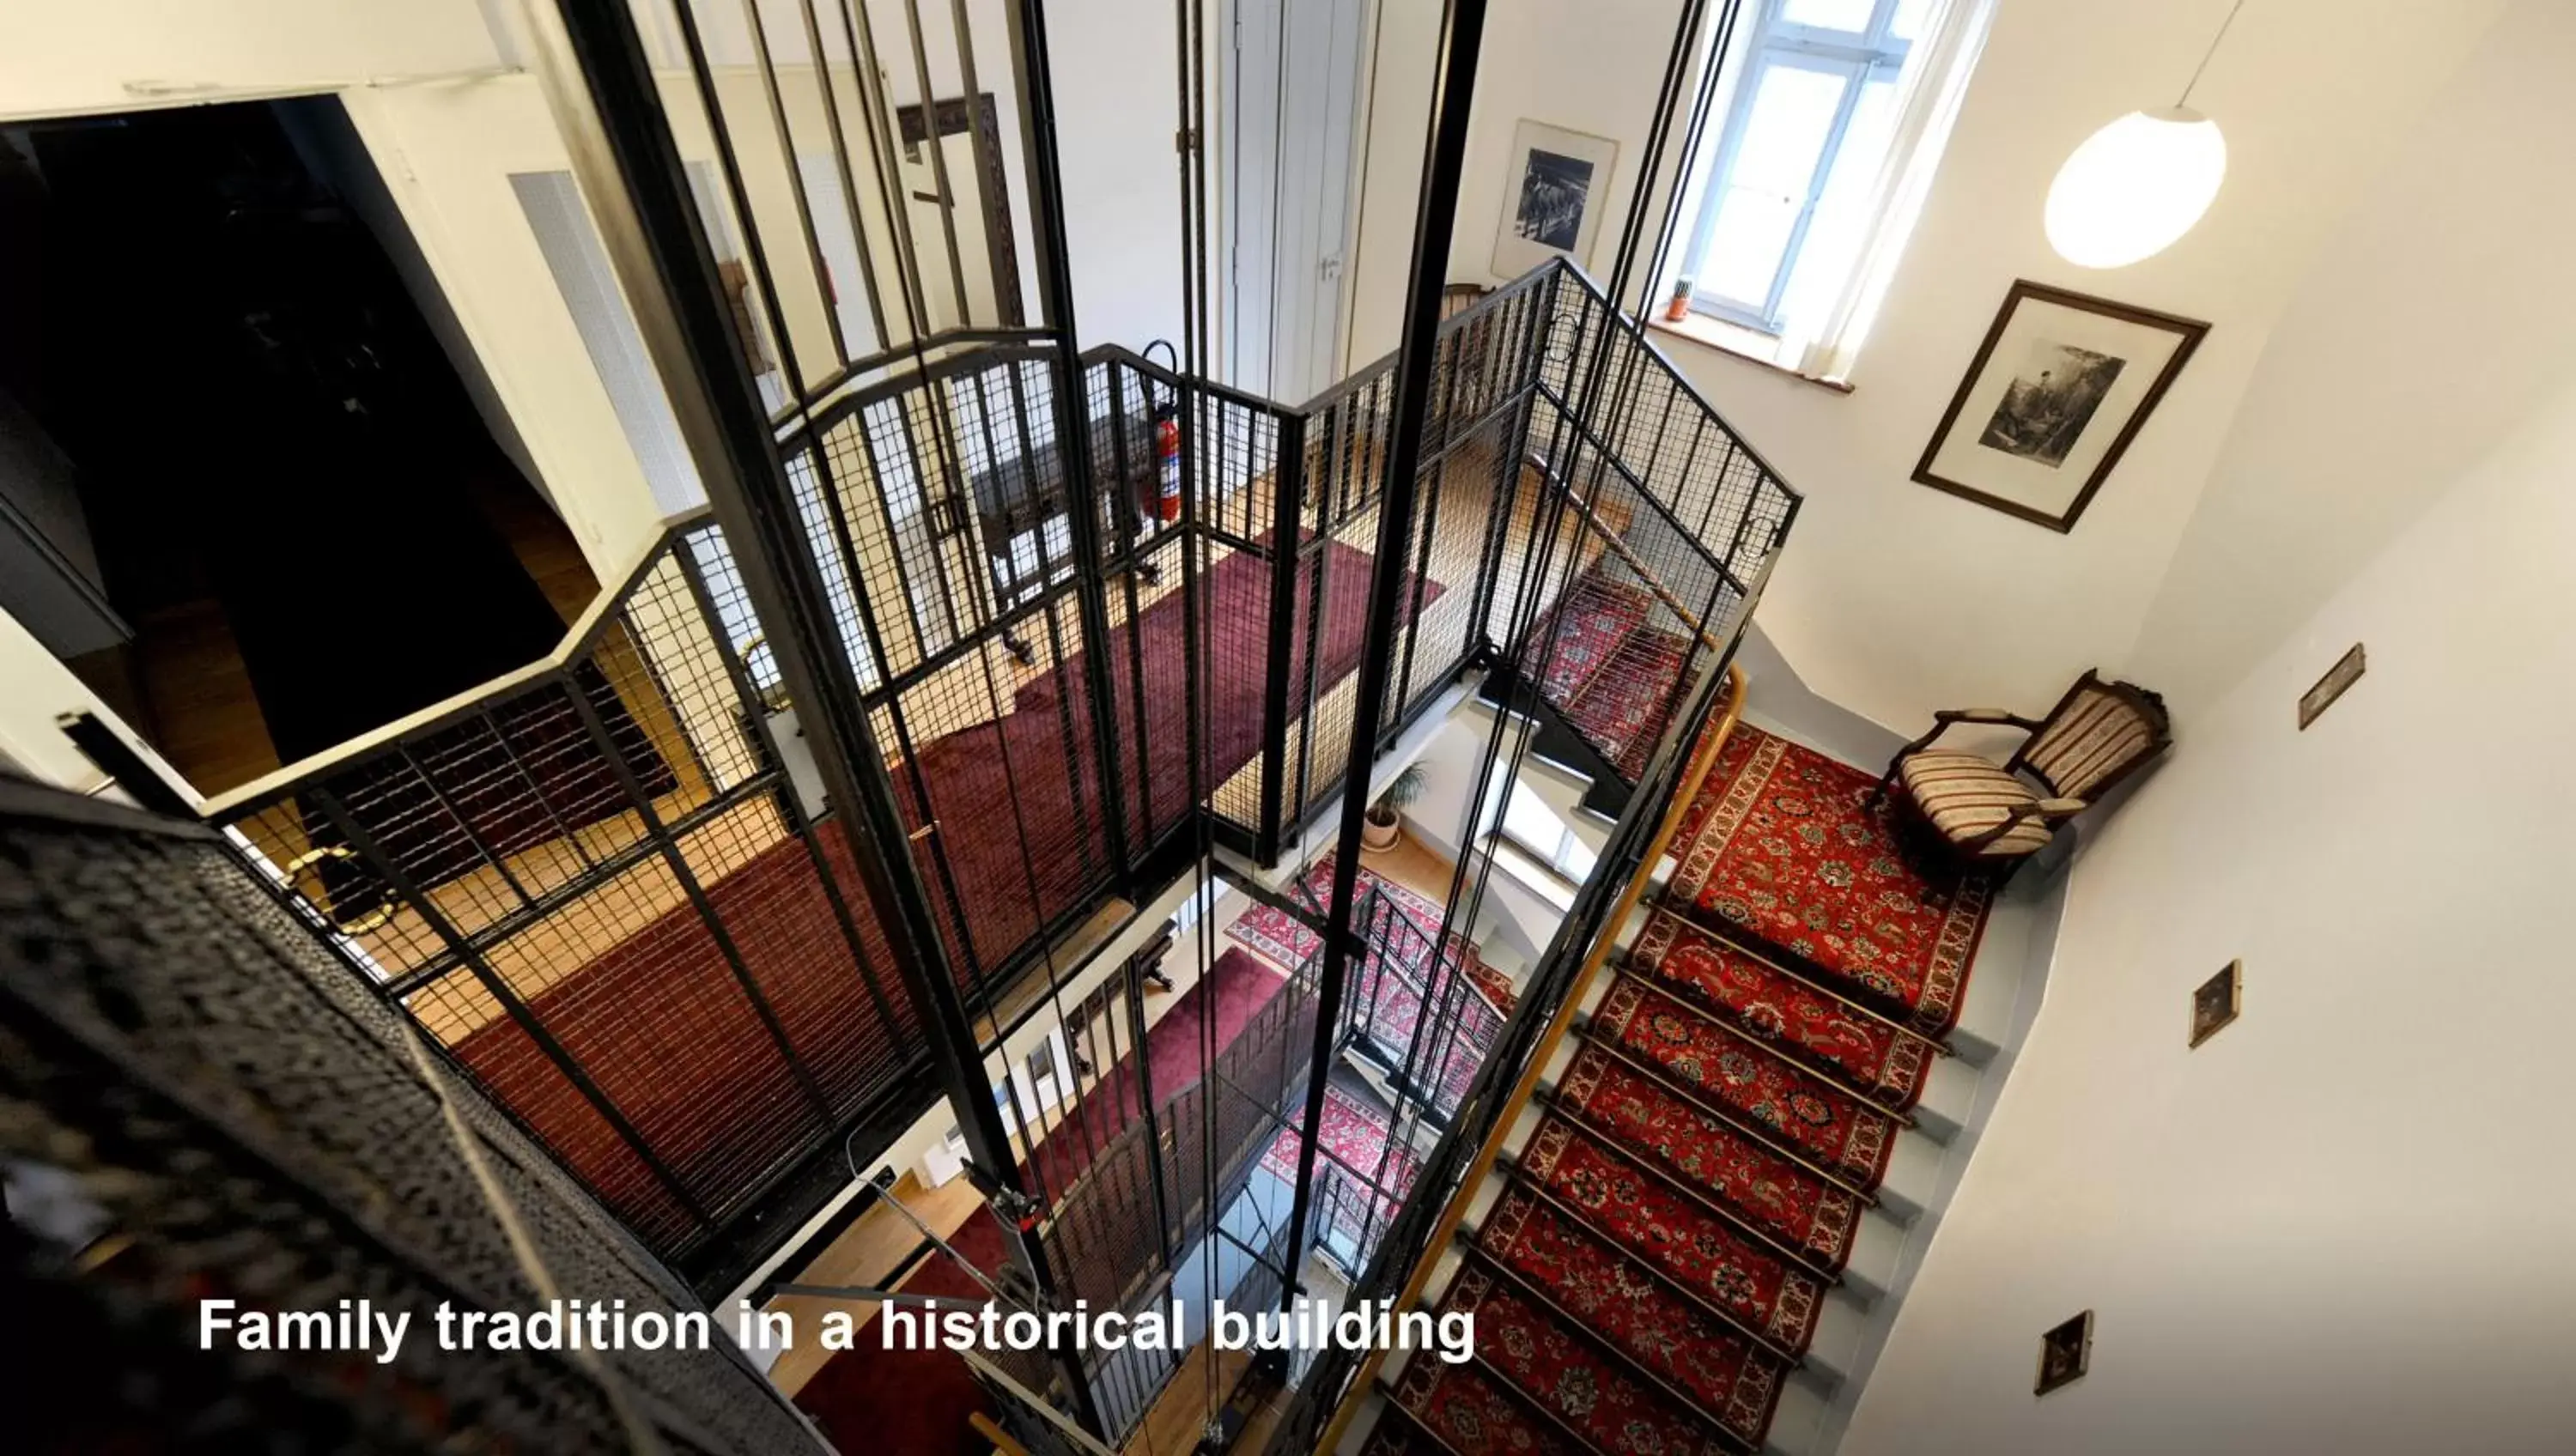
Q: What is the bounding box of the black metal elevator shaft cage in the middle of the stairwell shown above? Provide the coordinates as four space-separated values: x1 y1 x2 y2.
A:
50 0 1798 1441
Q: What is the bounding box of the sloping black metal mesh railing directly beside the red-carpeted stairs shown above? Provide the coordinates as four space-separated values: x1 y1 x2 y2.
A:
1267 268 1798 1456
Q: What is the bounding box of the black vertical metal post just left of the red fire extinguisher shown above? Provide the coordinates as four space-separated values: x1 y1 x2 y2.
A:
994 0 1144 887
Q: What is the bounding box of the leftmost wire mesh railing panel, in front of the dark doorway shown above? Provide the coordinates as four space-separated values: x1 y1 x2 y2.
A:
193 525 938 1258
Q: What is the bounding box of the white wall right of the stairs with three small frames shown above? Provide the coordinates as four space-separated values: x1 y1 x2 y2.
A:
1844 3 2576 1456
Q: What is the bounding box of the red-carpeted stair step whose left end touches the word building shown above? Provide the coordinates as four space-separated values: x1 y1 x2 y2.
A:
1440 1265 1739 1456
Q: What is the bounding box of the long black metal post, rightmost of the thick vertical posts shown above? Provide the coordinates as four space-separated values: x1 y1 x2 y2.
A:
1280 0 1484 1301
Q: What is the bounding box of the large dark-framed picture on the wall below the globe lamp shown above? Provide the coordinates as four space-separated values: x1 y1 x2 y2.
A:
1914 281 2210 531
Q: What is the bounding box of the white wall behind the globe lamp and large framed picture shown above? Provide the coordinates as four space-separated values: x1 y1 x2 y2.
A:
1360 0 2501 735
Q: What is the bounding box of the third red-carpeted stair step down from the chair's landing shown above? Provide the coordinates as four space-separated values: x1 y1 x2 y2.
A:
1556 1044 1865 1278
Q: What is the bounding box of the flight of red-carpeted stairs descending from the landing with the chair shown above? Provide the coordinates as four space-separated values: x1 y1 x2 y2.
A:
1334 675 2020 1456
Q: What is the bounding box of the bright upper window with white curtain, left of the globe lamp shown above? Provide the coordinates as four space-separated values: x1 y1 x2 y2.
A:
1677 0 1991 373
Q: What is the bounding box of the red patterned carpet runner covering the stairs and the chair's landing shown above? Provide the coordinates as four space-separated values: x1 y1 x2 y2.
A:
1368 721 1986 1456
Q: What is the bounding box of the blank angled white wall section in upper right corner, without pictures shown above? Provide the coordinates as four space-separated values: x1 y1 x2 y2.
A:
2138 3 2576 706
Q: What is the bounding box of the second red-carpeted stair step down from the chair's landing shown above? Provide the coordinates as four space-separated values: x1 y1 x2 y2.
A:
1584 974 1904 1191
